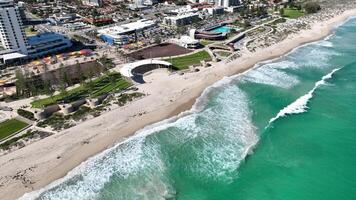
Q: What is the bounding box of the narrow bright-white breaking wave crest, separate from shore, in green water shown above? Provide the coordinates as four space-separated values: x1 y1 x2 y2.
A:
269 68 340 123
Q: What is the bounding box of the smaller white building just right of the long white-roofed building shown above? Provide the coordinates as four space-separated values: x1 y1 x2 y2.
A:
163 13 200 26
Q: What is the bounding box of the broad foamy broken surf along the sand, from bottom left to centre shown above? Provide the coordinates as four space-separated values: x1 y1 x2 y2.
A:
20 74 258 200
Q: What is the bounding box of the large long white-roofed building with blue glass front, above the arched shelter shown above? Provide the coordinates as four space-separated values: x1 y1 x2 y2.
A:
98 19 156 45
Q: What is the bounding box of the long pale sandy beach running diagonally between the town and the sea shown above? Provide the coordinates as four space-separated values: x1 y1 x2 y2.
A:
0 10 356 200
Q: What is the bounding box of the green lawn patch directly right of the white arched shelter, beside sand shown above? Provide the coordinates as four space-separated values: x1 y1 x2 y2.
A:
165 51 211 70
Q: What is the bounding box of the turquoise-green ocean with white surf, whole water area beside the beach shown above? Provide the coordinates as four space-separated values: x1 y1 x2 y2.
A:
22 19 356 200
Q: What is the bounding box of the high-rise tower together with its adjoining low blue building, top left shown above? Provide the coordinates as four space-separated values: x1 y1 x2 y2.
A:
0 0 72 63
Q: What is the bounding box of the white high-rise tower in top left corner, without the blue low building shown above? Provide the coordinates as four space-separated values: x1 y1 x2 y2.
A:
0 0 28 54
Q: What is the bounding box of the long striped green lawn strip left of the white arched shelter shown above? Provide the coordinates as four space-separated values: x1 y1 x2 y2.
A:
31 73 131 108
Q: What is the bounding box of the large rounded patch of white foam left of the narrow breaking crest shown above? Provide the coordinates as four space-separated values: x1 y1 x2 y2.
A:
189 86 258 181
